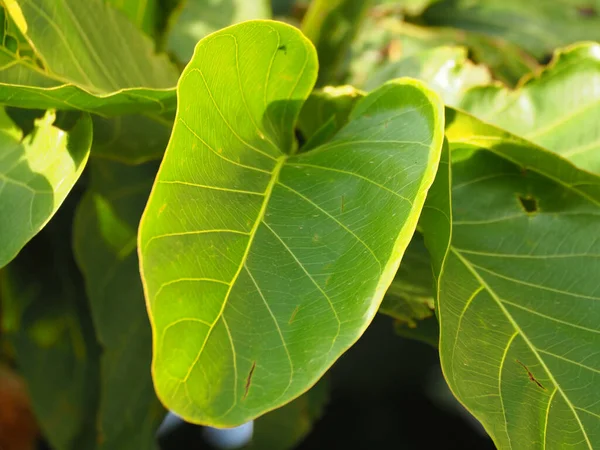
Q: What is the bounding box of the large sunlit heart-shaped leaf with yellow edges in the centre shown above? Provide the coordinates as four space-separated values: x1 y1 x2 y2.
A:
139 21 443 426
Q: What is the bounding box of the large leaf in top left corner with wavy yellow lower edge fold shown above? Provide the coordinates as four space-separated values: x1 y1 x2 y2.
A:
0 0 177 114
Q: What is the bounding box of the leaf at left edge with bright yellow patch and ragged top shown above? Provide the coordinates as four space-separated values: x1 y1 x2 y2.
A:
0 109 92 267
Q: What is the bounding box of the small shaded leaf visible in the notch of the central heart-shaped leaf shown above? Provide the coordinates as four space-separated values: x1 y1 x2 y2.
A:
297 86 365 151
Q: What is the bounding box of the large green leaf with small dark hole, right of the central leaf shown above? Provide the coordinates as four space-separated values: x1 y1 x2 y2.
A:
425 111 600 449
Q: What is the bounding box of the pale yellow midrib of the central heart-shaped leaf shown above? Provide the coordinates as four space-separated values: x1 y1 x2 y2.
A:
182 155 288 384
